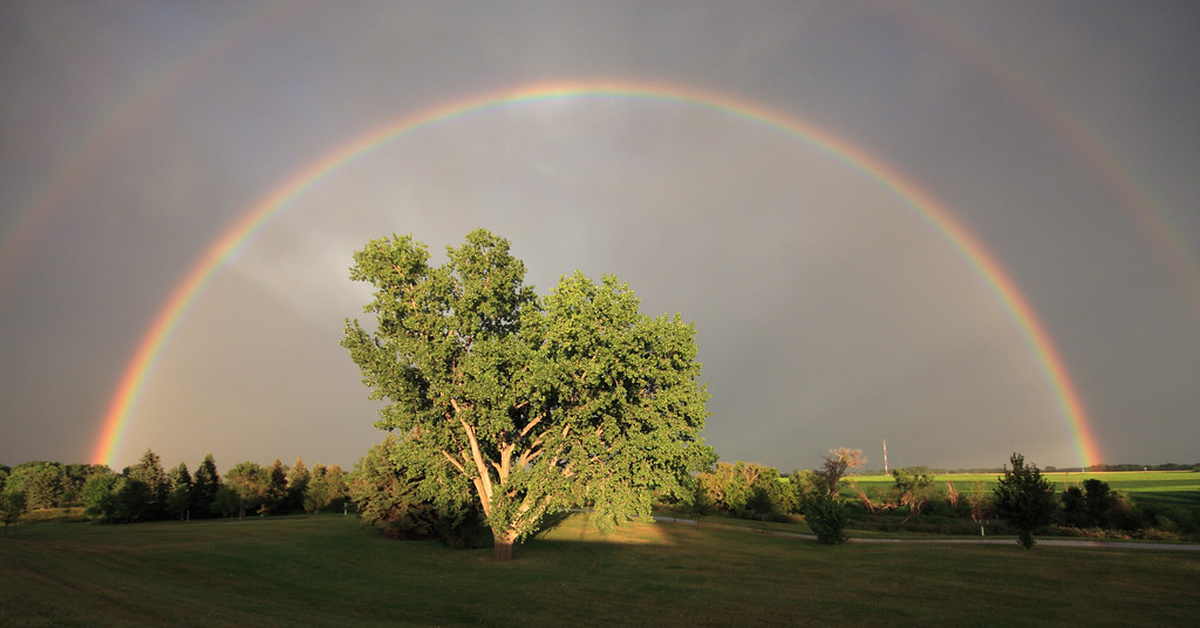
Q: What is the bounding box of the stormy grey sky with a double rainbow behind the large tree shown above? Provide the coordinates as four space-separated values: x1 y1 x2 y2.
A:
0 0 1200 471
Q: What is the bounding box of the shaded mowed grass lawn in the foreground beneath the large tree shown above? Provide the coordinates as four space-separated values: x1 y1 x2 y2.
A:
0 515 1200 627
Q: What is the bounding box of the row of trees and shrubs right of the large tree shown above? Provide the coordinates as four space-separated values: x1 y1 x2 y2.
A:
682 448 1200 543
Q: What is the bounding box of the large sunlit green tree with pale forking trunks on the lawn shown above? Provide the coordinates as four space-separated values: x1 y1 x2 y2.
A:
342 229 710 561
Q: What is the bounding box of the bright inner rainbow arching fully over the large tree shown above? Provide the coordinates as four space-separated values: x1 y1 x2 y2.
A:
91 80 1100 466
